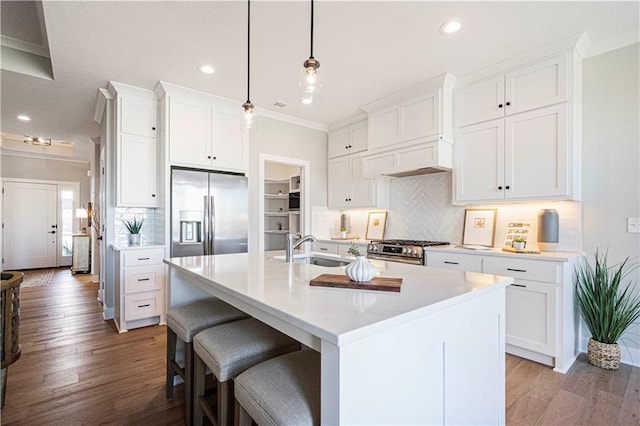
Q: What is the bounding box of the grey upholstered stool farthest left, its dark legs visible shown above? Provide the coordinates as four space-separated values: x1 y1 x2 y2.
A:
166 298 248 424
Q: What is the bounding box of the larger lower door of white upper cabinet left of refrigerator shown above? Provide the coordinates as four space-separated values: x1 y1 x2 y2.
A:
117 133 158 207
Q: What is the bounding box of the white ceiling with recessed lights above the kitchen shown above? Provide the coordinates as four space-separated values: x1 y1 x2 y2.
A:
0 0 640 158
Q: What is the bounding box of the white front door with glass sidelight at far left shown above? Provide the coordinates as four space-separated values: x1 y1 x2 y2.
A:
2 179 81 270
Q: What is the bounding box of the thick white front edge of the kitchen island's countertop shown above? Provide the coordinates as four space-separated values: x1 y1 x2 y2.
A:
164 252 514 346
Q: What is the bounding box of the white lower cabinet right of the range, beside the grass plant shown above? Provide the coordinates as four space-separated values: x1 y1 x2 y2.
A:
427 250 578 373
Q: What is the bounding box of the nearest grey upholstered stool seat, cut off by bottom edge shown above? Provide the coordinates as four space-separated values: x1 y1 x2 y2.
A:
235 350 320 426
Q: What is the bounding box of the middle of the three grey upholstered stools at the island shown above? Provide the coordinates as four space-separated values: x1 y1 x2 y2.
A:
193 318 300 425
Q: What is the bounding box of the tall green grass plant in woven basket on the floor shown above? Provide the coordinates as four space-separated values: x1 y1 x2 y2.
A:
574 251 640 370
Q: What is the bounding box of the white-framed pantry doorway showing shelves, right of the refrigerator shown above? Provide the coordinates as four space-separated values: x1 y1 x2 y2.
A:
258 154 311 251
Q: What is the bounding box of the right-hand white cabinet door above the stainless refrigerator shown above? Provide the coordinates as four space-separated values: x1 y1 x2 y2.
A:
211 111 246 170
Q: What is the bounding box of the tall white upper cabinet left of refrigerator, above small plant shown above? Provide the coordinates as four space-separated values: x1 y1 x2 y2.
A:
109 82 159 208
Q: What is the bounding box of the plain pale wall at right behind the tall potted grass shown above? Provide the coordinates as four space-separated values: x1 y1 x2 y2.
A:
582 44 640 366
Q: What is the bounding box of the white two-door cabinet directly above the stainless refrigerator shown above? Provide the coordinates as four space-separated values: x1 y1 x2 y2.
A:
156 82 249 173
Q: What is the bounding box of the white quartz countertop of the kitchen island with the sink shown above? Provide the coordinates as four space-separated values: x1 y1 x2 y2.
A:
164 251 513 346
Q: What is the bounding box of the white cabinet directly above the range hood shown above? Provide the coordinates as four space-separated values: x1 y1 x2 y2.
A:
362 74 454 151
